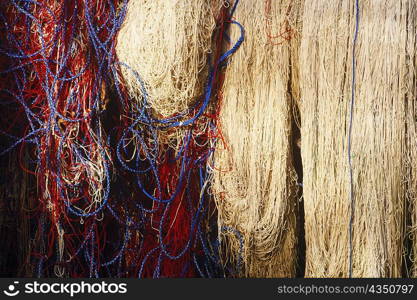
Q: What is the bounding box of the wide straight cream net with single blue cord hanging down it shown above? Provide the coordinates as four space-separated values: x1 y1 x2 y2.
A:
300 0 408 277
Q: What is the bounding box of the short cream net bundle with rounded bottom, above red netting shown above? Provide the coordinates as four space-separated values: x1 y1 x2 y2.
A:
116 0 223 117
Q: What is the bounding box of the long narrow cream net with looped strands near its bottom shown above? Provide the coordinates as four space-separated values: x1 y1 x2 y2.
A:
213 0 299 277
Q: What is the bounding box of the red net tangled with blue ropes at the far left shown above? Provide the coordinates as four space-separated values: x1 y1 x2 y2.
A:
2 0 127 277
